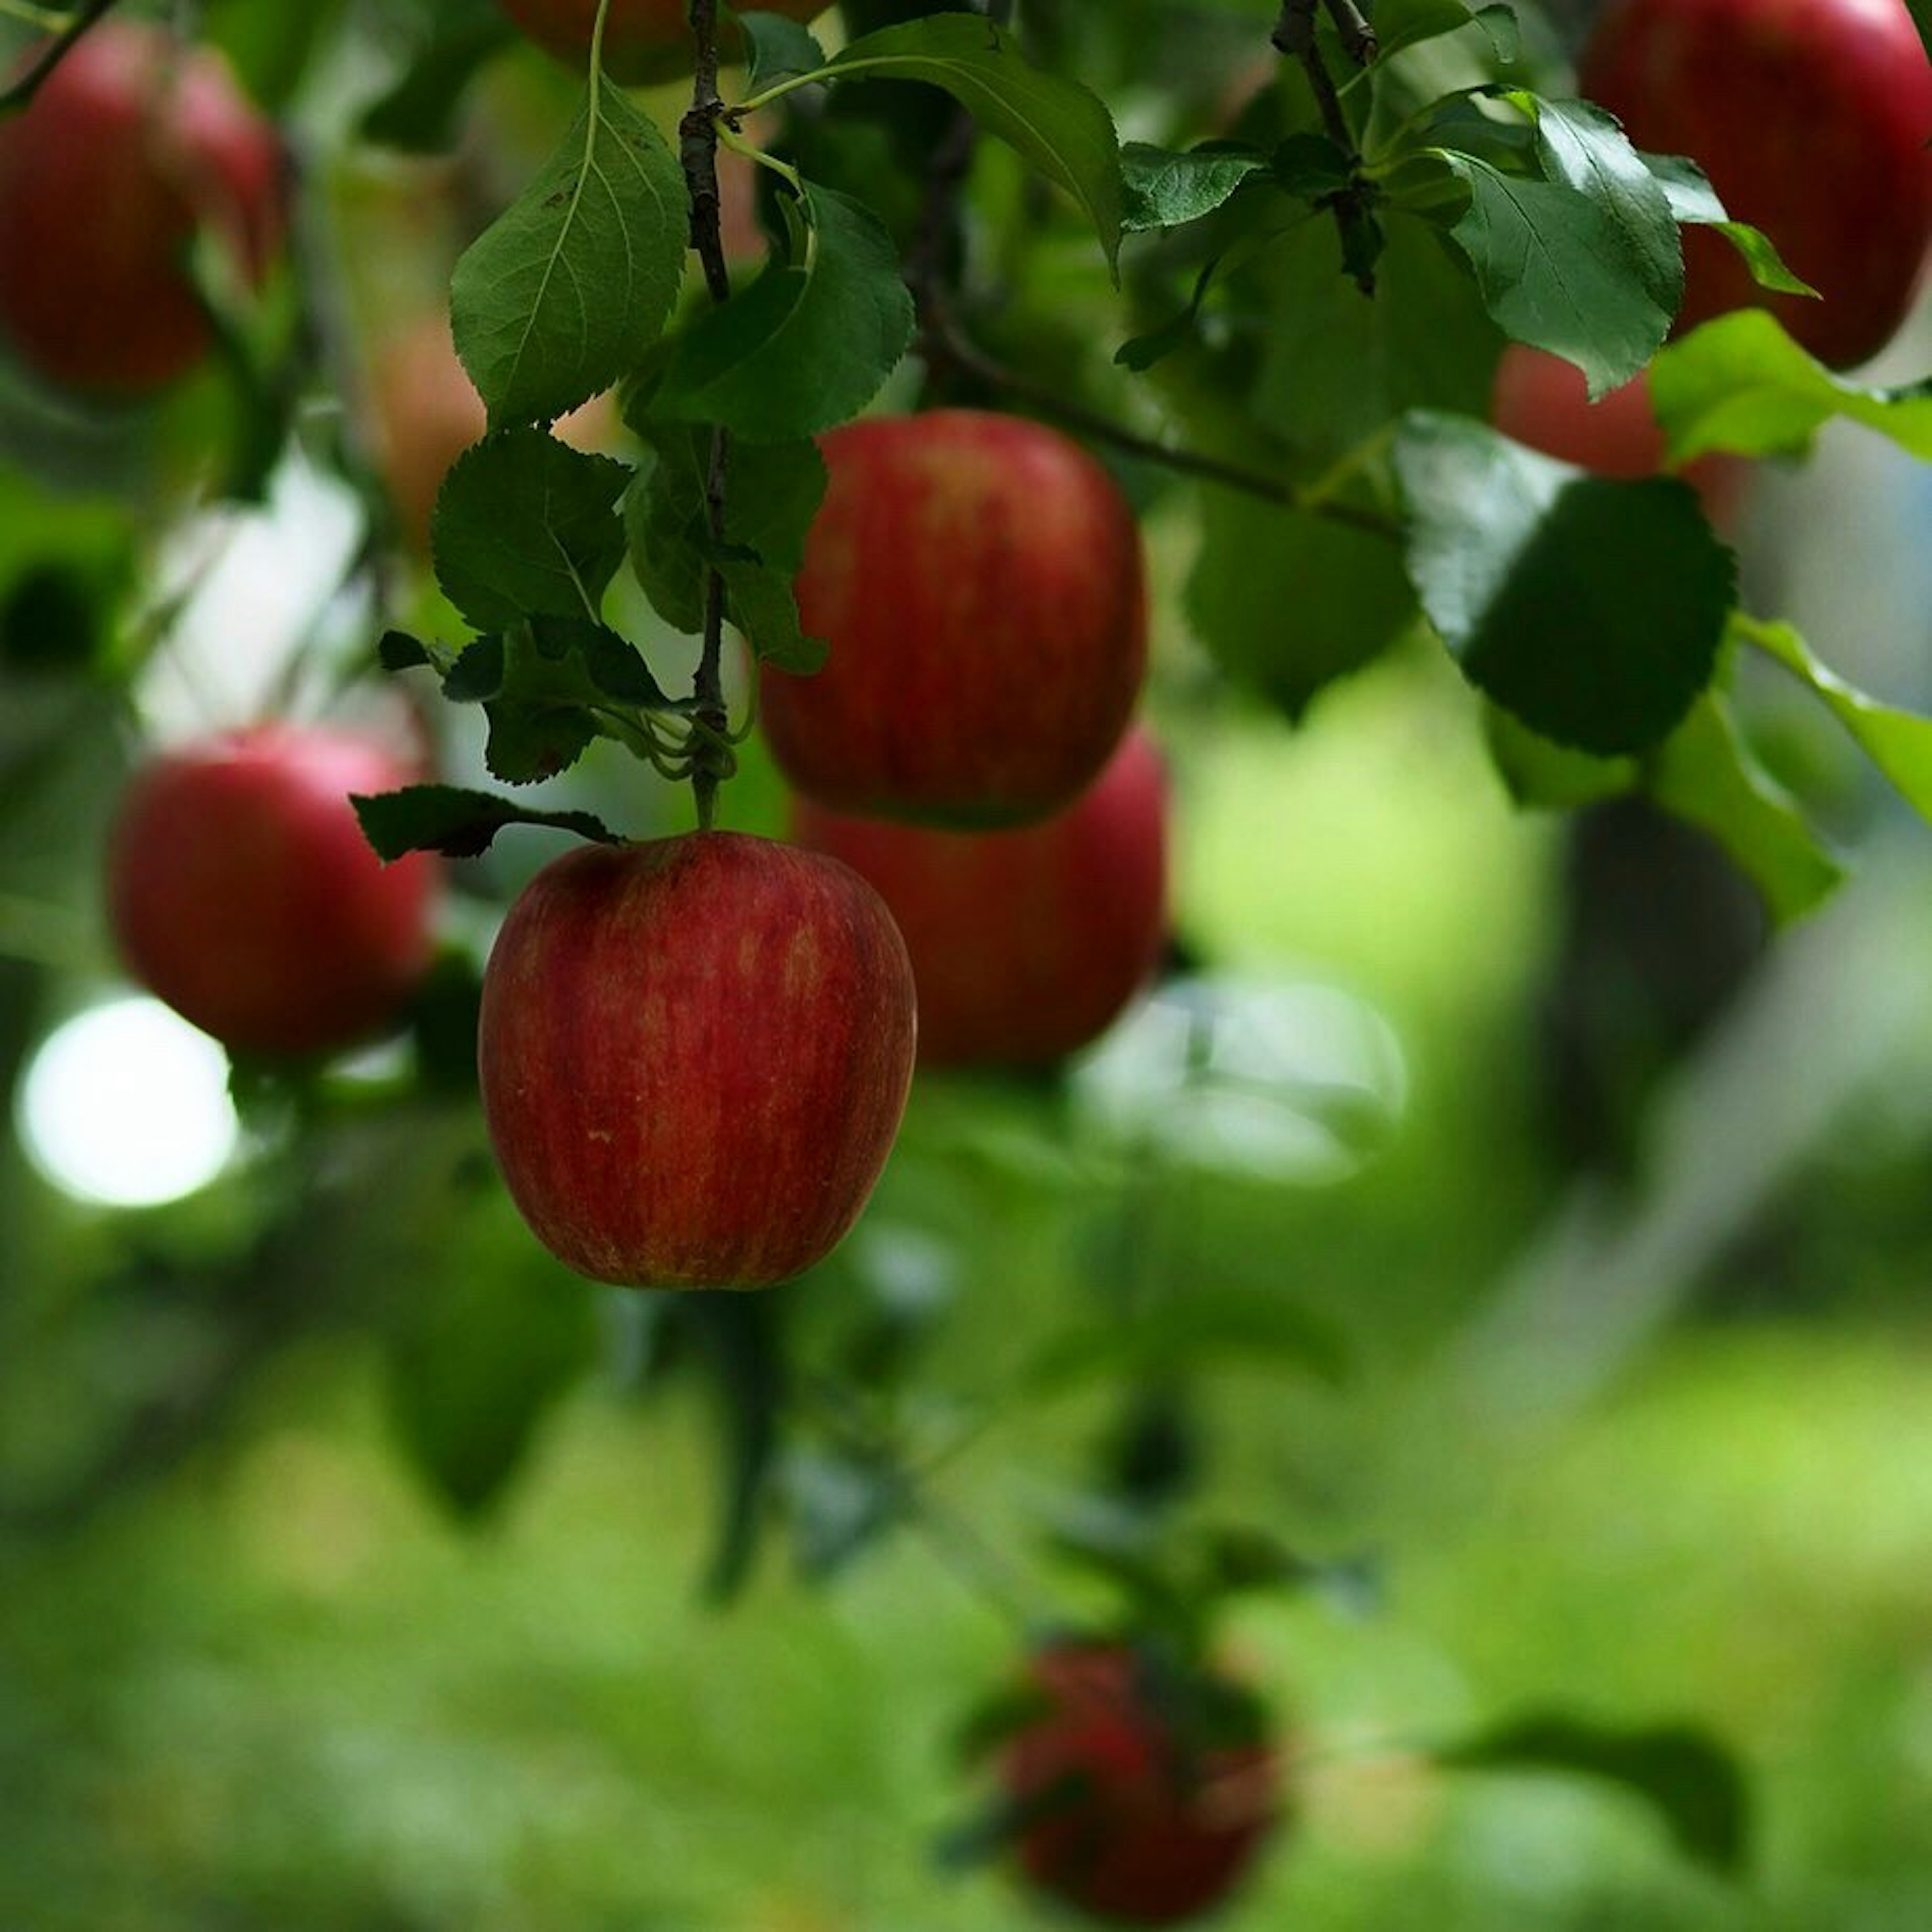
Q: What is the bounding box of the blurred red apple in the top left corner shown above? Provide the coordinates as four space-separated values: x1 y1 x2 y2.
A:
0 19 284 398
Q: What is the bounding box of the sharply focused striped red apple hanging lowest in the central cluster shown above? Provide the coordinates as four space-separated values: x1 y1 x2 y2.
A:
477 831 916 1289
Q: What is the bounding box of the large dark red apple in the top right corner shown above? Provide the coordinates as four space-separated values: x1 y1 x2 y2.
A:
1578 0 1932 369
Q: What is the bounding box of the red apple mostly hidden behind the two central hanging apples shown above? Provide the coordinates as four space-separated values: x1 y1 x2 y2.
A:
792 727 1167 1067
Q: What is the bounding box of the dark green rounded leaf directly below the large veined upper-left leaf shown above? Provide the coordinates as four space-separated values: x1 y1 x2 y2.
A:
429 429 630 630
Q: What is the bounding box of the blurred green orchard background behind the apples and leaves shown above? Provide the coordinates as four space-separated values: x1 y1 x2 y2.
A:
0 6 1932 1932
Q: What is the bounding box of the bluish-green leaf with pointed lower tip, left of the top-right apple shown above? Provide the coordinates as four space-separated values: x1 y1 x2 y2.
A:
1431 149 1671 396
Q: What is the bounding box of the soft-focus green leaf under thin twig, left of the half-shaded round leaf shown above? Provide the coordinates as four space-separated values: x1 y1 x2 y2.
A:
1186 489 1416 718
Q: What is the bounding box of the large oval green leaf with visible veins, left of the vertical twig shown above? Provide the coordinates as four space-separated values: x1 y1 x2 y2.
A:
450 83 690 429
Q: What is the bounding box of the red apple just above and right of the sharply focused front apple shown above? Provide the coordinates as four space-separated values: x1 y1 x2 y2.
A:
761 410 1148 827
